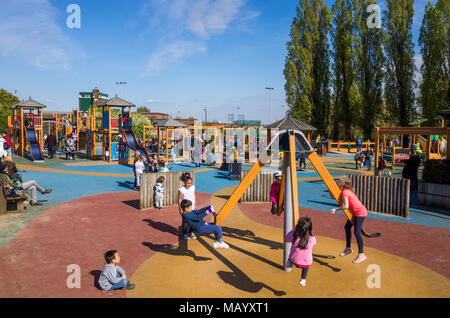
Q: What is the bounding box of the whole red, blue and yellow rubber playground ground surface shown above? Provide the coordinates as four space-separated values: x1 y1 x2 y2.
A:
0 123 450 298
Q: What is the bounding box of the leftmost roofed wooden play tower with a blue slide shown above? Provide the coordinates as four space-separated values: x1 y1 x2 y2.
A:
8 97 45 161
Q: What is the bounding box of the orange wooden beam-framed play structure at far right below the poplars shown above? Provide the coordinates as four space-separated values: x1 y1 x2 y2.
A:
374 127 450 175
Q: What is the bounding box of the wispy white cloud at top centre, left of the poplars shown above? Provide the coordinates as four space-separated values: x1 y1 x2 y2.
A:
141 0 246 75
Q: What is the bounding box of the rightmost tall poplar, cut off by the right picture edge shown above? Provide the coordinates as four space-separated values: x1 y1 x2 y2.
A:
419 0 450 122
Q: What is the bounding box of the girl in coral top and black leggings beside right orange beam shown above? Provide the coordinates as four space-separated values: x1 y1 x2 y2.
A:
331 176 367 264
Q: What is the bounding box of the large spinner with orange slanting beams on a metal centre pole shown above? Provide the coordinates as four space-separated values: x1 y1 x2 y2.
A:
210 130 380 271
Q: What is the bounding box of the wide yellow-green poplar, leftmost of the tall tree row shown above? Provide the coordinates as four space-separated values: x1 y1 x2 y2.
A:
284 0 332 129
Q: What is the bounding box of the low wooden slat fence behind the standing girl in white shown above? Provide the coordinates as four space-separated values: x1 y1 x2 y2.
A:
139 170 195 210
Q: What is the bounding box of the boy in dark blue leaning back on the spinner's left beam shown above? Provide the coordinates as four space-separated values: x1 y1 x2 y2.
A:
181 200 229 248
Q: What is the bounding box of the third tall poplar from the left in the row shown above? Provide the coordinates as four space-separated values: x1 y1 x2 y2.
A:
354 0 384 138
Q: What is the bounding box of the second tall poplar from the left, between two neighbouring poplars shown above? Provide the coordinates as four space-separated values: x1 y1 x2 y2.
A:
332 0 361 138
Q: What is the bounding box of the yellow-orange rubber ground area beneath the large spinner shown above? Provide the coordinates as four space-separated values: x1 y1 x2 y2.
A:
127 187 450 298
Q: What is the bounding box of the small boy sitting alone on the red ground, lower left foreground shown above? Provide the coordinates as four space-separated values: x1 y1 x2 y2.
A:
98 250 135 291
